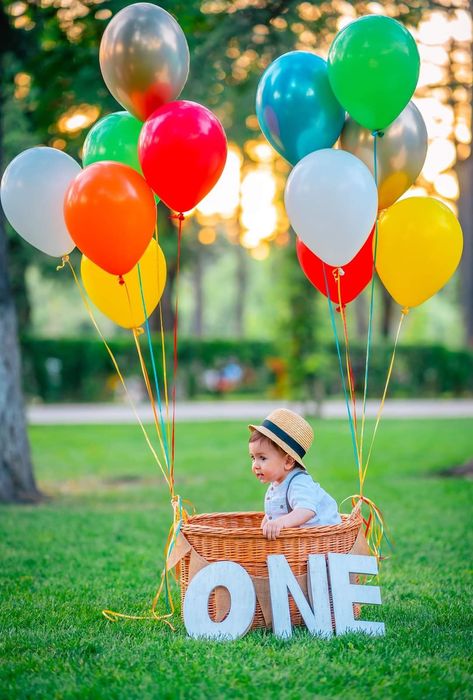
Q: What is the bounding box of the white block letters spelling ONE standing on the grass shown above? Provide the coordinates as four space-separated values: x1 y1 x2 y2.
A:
183 553 385 640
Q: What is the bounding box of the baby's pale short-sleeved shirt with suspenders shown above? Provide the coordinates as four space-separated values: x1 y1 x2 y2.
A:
264 467 342 527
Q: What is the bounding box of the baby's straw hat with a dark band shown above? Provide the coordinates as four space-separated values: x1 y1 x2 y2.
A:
248 408 314 469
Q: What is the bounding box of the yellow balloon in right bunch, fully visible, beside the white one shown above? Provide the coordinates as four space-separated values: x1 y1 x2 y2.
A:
376 197 463 308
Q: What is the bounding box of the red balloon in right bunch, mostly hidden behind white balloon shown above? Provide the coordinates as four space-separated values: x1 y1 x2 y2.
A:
296 228 374 306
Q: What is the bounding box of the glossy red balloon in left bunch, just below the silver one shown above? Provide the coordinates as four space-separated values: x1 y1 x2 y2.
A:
138 100 227 213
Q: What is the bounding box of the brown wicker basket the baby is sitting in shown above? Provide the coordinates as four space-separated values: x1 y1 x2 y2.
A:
181 509 362 629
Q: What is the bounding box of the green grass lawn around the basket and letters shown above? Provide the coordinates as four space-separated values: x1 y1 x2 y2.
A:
0 420 473 700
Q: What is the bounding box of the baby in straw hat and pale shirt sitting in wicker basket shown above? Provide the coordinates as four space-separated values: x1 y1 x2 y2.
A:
248 408 341 540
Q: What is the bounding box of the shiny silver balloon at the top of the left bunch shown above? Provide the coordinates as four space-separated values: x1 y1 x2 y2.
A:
100 2 189 121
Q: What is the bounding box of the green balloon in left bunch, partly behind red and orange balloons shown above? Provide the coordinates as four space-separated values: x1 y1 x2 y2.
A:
82 112 143 175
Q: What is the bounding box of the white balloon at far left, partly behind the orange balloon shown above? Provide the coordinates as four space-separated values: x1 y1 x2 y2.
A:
0 146 81 258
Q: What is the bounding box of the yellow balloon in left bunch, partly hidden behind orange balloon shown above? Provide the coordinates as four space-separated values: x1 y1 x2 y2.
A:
80 238 166 328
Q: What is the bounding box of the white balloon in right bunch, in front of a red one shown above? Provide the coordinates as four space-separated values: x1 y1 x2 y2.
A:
284 148 378 267
